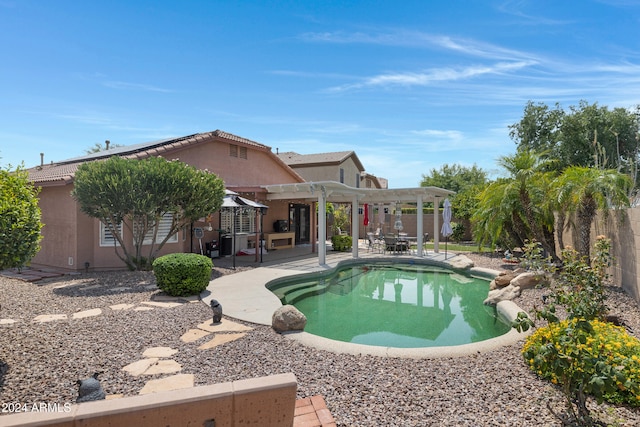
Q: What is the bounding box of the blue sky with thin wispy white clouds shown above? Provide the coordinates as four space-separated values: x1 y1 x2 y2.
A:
0 0 640 188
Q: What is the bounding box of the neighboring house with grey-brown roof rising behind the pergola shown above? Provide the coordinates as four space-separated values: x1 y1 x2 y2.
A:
278 151 387 188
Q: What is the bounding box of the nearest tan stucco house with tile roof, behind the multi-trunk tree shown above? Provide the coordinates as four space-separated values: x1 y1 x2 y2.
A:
28 130 311 270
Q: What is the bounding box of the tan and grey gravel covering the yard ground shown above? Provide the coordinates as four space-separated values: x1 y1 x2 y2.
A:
0 254 640 426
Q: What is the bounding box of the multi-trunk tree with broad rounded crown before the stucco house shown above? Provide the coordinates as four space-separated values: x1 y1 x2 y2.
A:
72 156 224 270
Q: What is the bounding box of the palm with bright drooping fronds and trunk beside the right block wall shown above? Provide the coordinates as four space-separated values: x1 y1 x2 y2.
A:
554 166 632 257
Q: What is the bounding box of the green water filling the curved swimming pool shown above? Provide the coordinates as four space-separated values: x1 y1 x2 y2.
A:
268 264 510 348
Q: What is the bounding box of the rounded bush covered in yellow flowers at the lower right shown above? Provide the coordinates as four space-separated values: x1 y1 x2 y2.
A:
522 318 640 409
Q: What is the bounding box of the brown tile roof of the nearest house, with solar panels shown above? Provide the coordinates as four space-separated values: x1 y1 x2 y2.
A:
27 130 271 185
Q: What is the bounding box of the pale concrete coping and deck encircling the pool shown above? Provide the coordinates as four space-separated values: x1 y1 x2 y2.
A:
201 254 531 359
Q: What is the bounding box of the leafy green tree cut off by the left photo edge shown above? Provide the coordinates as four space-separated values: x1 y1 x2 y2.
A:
0 168 42 270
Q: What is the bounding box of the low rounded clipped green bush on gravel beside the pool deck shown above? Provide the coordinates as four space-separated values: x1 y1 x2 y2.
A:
153 253 213 296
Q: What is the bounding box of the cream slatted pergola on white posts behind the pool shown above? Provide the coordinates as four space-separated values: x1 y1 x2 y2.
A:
263 181 454 265
